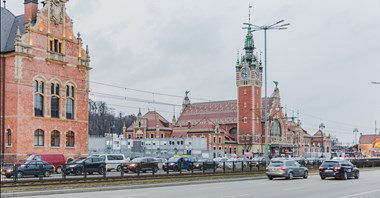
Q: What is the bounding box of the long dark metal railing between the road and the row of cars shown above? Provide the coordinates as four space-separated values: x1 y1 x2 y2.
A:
1 159 380 184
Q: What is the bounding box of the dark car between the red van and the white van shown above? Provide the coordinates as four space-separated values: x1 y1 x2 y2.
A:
64 156 106 175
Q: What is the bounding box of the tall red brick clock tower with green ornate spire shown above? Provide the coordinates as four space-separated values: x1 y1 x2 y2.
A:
236 10 262 155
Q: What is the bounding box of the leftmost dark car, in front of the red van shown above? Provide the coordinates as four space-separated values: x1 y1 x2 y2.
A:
2 160 54 178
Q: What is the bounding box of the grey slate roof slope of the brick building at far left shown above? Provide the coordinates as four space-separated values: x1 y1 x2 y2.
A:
0 7 25 53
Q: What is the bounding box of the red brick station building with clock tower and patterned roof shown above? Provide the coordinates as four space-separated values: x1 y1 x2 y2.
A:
125 18 300 156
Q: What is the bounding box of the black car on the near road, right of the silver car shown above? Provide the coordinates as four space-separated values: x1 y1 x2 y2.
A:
319 159 359 180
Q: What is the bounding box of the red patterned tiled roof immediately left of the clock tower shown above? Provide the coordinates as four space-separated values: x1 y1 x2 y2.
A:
176 100 237 127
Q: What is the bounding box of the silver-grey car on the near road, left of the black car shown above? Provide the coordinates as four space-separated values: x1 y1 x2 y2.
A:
265 159 309 180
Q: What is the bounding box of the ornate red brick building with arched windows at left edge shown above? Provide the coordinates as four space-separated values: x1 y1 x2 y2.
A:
0 0 91 161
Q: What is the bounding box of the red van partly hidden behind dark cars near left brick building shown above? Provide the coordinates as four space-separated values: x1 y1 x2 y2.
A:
26 153 66 174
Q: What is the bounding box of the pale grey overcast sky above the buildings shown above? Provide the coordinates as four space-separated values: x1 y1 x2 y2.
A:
7 0 380 143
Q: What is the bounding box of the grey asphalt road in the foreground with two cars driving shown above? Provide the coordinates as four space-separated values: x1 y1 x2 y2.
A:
6 170 380 198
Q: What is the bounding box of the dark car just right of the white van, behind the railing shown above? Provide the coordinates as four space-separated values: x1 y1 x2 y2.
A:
123 157 158 173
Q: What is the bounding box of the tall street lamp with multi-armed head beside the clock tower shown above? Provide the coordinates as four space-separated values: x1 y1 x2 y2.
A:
243 20 290 165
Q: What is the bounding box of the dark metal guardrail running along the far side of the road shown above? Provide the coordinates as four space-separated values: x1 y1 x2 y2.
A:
1 159 380 186
